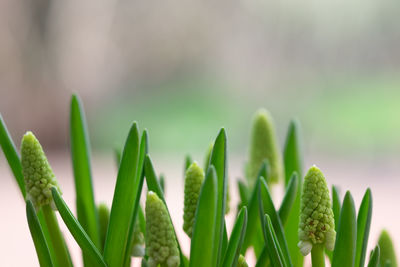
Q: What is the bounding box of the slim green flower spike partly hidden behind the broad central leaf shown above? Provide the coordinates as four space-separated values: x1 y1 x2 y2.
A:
183 162 204 237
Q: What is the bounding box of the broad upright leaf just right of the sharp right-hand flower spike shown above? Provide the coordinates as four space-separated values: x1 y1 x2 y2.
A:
332 191 357 267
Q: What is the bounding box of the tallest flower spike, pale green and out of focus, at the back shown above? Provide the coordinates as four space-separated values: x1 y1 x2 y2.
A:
246 109 284 185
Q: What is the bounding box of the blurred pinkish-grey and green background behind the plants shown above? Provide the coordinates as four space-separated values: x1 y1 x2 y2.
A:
0 0 400 266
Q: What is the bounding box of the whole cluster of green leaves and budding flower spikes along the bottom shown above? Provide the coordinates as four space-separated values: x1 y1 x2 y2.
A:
0 96 397 267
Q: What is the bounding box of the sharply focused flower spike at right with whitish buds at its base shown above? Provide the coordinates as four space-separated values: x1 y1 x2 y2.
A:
298 166 336 255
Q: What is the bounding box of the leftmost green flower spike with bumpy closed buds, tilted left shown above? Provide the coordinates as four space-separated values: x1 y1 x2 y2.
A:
21 132 61 209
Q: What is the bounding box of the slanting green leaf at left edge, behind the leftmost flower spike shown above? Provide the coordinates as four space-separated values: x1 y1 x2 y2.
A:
0 114 26 199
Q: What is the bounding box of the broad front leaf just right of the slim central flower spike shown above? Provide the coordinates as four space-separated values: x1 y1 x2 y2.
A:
189 168 219 267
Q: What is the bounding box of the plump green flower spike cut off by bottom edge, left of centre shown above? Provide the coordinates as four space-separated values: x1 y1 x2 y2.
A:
145 191 180 267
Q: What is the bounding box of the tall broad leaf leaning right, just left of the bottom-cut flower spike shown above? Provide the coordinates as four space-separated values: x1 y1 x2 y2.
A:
104 123 143 267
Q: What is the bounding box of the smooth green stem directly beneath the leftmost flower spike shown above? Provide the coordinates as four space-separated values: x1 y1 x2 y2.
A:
42 205 72 267
